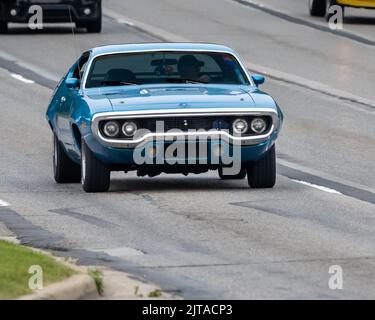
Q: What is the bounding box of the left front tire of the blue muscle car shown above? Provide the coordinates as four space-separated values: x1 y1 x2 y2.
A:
81 139 111 192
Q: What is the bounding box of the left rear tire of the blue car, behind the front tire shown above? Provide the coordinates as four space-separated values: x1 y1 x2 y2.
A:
53 134 81 183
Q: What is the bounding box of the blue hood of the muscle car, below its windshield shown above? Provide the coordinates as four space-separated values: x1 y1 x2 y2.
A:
89 85 255 111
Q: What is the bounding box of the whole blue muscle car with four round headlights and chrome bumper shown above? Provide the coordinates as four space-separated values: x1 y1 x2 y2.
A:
47 43 283 192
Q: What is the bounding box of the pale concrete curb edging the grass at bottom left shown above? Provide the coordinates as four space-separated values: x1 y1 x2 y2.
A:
18 275 98 300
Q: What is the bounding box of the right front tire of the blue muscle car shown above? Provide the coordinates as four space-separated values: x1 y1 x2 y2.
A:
247 145 276 188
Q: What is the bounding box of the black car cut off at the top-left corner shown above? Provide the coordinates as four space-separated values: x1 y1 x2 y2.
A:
0 0 102 33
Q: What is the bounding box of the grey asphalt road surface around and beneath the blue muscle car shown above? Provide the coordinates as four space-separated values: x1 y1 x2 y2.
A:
0 0 375 299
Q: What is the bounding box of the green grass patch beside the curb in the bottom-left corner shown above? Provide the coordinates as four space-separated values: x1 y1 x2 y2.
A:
0 240 77 299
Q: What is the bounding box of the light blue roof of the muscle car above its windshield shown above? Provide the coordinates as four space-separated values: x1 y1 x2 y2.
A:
90 42 235 56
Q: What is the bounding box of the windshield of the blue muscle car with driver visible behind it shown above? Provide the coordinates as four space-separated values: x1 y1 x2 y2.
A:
86 51 249 88
